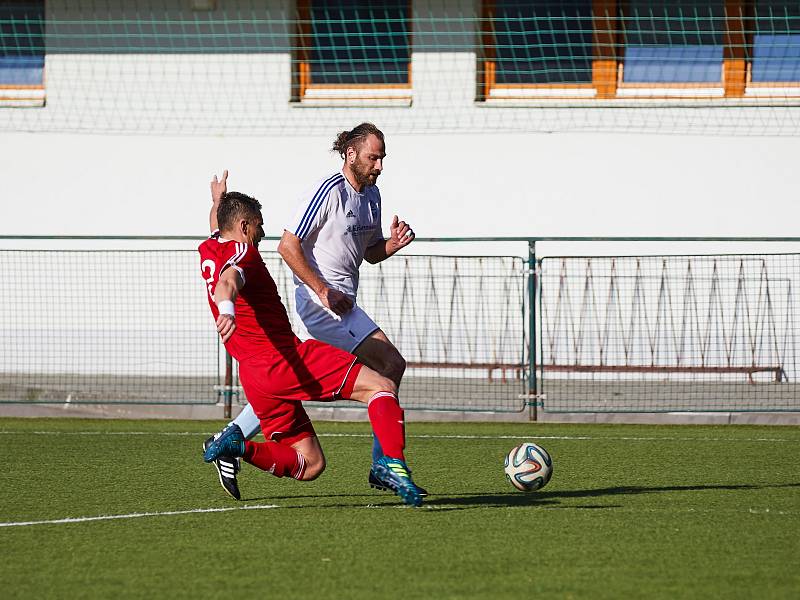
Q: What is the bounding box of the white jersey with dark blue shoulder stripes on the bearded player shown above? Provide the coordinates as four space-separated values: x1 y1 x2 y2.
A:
286 172 383 300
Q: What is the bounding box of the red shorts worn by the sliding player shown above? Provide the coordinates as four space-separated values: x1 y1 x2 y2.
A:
239 340 362 444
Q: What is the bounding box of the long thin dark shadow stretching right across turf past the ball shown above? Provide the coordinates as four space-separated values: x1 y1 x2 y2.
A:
426 483 800 509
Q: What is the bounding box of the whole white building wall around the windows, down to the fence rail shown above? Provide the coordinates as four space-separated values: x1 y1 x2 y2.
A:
0 0 800 253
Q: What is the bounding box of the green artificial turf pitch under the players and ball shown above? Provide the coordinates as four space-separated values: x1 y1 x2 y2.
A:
0 419 800 599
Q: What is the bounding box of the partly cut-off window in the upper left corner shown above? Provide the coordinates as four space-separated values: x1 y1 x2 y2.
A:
0 0 44 106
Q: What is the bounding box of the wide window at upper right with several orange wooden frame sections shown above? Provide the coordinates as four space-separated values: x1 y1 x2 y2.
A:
477 0 800 103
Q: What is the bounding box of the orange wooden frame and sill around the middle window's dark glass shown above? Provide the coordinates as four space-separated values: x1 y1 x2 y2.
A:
291 0 414 106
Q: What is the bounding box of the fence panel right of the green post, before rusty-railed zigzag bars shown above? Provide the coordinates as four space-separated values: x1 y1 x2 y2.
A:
539 254 800 412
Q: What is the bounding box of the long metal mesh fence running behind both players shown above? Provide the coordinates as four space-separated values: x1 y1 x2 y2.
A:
0 237 800 418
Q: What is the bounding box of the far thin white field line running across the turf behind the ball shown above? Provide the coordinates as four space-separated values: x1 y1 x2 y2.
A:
0 430 800 444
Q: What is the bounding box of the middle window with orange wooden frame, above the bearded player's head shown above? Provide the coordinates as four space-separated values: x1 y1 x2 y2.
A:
292 0 411 104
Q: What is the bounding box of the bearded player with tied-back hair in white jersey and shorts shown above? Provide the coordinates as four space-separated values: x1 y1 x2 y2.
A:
203 123 427 497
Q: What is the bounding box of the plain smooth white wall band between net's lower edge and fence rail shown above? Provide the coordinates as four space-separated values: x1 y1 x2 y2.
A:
0 131 800 253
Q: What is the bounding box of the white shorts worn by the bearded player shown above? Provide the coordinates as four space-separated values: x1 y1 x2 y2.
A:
294 285 380 352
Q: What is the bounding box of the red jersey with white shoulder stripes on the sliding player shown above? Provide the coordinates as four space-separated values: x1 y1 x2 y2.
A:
198 233 300 363
